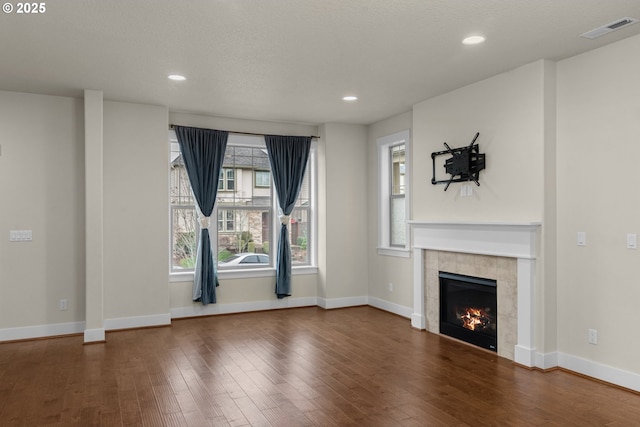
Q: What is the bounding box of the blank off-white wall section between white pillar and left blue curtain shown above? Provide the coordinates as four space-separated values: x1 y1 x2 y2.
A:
103 101 169 326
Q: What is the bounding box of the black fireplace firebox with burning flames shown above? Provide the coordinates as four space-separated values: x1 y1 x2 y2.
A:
439 271 498 352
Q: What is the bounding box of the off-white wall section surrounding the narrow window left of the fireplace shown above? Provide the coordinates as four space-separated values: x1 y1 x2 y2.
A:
367 111 421 317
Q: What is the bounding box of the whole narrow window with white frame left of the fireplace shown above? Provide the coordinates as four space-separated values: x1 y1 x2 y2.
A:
378 130 409 257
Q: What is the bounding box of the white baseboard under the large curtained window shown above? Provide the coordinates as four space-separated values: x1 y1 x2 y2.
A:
170 297 318 319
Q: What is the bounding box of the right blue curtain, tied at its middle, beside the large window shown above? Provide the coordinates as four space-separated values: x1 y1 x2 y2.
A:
264 135 311 298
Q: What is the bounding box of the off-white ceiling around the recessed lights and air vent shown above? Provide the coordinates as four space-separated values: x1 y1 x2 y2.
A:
0 0 640 124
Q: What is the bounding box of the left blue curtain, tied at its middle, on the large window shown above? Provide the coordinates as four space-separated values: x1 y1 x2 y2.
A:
174 126 229 305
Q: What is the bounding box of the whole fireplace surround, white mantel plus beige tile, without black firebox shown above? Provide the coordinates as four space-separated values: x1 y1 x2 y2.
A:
410 221 540 367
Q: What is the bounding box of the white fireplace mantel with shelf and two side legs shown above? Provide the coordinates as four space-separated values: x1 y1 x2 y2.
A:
409 221 541 367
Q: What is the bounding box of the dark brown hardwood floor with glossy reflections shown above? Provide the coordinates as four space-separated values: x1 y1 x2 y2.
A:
0 307 640 427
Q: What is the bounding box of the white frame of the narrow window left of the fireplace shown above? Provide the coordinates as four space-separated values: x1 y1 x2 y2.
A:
377 129 411 258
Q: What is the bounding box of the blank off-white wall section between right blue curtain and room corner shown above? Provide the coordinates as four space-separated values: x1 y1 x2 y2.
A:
318 123 368 308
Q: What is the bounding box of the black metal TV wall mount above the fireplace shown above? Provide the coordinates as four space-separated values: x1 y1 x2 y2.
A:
431 132 485 191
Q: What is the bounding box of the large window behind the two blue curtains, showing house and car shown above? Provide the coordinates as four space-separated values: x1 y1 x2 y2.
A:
169 131 315 273
